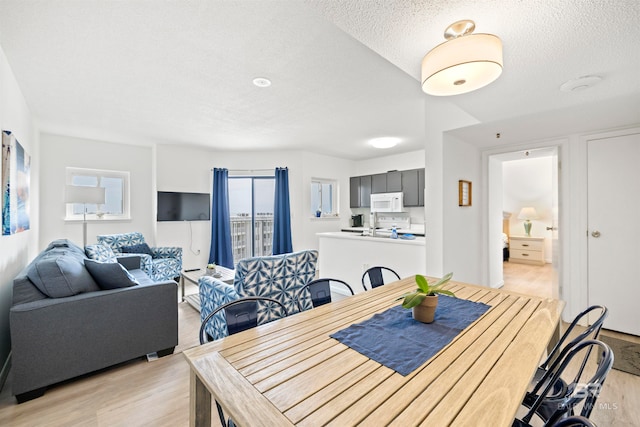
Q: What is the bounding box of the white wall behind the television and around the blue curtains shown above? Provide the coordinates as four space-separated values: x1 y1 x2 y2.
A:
156 145 353 268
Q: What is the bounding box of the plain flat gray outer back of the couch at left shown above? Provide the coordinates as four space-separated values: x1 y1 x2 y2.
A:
9 281 178 395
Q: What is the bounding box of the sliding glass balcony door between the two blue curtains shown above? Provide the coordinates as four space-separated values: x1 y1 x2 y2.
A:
229 176 275 264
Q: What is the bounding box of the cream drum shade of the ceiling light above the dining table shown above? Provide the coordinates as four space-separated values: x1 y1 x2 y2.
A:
422 34 503 96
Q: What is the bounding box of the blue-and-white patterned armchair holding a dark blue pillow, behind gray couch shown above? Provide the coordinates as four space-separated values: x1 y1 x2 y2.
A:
94 232 182 281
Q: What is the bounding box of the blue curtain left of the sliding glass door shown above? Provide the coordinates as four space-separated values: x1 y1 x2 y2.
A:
209 168 233 269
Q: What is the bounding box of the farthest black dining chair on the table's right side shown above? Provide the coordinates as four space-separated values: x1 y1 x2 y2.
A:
531 305 609 395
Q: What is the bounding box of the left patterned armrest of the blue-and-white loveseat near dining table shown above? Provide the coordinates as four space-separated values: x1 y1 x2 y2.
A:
198 276 240 340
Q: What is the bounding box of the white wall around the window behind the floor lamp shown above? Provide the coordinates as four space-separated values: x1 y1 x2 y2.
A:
40 133 155 248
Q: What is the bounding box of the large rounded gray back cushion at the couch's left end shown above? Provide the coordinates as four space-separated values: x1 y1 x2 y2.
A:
27 254 100 298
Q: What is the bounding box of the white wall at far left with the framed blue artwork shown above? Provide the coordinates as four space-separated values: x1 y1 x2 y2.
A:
0 44 41 387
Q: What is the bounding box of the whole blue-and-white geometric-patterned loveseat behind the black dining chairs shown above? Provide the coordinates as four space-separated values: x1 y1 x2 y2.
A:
198 250 318 340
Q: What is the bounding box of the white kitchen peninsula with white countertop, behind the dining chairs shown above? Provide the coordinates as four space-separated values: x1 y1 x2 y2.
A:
317 232 427 293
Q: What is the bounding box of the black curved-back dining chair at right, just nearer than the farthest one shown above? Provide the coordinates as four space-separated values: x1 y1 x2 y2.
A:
513 340 613 427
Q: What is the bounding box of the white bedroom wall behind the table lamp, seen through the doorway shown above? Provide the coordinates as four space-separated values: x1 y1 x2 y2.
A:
502 157 553 263
